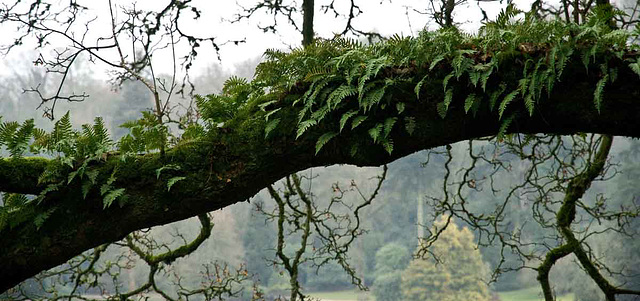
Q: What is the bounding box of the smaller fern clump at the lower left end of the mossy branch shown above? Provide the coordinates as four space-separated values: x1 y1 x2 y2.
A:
0 112 126 230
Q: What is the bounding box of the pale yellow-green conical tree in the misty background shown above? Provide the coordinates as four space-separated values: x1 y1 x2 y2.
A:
401 218 490 301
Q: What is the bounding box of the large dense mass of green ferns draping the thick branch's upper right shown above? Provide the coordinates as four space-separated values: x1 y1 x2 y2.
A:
198 6 640 153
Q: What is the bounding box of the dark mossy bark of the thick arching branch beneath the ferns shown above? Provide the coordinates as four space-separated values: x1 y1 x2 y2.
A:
0 55 640 291
